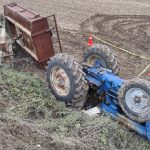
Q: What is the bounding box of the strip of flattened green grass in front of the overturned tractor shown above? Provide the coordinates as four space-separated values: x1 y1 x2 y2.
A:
0 67 150 150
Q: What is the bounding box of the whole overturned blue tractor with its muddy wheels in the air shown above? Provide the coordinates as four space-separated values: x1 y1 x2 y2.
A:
46 45 150 140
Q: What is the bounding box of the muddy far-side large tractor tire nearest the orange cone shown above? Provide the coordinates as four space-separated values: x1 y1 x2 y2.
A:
83 44 119 74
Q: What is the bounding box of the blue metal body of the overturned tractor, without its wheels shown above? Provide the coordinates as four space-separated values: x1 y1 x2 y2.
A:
85 63 150 140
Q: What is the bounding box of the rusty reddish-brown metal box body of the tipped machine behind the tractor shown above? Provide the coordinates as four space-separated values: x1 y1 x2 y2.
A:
4 3 55 63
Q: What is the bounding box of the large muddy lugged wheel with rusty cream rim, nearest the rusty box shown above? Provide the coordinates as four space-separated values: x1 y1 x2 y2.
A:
46 54 89 108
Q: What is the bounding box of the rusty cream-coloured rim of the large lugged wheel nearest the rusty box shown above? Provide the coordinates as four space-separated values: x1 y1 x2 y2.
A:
50 66 70 96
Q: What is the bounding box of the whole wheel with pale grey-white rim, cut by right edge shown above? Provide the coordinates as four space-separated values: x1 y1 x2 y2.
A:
118 79 150 122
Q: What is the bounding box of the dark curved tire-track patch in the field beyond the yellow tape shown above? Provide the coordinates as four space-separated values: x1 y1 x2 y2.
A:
81 15 150 56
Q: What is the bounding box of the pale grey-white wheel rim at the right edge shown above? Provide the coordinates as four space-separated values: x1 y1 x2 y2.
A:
125 88 150 114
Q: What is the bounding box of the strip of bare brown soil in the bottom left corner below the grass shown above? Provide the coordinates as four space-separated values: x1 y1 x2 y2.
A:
0 114 86 150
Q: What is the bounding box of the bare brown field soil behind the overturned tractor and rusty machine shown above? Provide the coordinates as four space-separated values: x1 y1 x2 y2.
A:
0 0 150 80
